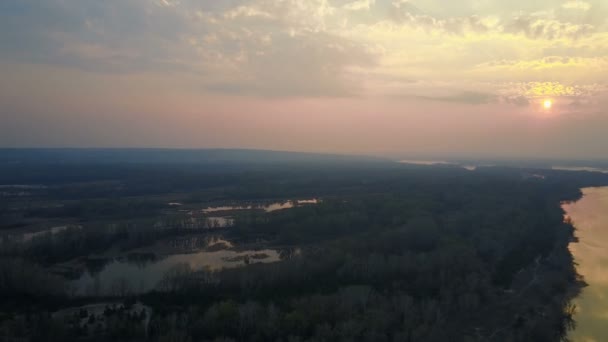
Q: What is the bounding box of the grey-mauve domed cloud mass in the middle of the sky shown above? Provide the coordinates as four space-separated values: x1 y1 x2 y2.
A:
207 33 374 97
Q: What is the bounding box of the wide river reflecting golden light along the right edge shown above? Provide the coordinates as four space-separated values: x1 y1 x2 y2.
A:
563 187 608 342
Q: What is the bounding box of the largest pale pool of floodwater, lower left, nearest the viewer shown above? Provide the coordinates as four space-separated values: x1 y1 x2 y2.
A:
66 236 281 295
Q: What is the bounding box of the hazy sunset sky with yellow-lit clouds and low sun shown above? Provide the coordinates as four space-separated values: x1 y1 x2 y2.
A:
0 0 608 159
